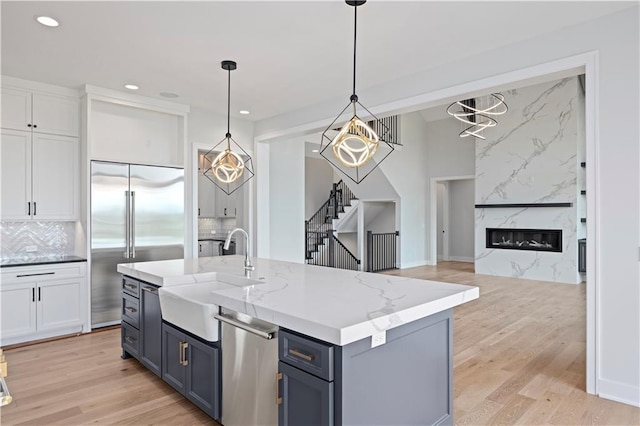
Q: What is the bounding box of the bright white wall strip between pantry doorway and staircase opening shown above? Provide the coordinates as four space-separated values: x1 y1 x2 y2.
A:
269 140 305 263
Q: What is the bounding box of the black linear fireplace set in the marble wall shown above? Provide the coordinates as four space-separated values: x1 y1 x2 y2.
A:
487 228 562 252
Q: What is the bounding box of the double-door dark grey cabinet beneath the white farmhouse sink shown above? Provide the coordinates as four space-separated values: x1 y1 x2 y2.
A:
162 322 220 419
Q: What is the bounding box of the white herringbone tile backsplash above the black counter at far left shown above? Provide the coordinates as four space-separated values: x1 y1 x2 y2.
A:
0 222 75 259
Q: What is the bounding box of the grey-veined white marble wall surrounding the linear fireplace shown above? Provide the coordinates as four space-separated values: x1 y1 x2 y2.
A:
475 77 584 283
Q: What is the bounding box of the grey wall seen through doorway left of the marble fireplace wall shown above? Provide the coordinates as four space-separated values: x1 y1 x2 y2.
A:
448 179 475 262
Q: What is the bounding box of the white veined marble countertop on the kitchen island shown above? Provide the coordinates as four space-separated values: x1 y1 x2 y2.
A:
118 255 479 345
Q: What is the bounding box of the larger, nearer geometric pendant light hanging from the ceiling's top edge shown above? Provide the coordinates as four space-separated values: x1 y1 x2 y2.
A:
320 0 393 183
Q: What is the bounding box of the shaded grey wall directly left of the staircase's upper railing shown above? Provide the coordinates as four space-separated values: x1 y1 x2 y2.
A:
304 157 337 219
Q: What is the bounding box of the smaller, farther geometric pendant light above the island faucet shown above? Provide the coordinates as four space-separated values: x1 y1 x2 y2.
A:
203 61 254 195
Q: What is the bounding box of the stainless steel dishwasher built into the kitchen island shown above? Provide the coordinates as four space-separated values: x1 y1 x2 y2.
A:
215 309 278 426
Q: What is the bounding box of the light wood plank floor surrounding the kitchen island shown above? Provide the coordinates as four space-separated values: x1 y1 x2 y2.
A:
0 262 640 426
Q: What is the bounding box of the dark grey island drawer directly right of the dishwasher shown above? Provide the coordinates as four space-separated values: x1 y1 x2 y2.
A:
278 329 333 381
